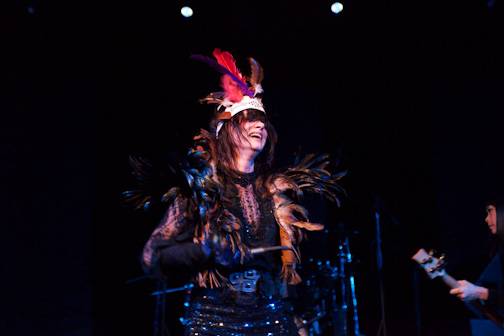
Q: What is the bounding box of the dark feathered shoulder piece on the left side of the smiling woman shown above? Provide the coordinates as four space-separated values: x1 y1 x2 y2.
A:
126 130 234 287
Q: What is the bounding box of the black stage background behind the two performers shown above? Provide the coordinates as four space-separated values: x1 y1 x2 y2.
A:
0 0 504 335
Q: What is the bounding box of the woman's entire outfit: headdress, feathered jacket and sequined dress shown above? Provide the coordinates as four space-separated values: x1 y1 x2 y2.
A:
127 50 344 336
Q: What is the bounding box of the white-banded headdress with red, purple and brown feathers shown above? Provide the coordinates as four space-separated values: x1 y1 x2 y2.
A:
191 49 266 136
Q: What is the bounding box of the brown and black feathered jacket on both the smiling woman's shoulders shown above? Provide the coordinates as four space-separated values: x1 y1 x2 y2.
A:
132 130 345 288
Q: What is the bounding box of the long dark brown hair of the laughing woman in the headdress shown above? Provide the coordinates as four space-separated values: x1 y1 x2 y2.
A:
211 109 277 176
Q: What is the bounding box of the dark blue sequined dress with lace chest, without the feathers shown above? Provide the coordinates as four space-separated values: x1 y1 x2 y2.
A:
144 169 297 335
